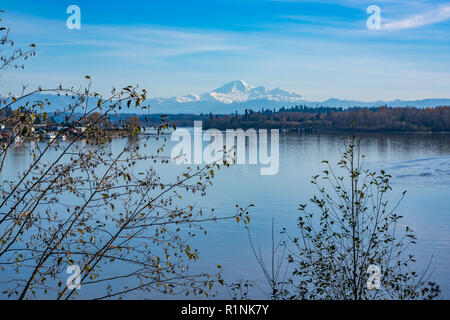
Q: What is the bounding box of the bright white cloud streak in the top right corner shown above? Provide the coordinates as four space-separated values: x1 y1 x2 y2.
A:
383 5 450 30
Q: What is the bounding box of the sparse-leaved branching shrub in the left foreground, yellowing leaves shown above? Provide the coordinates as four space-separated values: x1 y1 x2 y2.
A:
0 10 249 299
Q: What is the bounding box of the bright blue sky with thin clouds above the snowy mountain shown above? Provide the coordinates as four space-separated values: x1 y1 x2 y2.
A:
0 0 450 101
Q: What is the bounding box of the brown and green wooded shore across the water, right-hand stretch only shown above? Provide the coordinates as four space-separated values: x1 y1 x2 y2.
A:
203 106 450 132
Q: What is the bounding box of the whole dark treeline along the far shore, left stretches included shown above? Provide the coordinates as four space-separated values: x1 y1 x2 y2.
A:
0 106 450 132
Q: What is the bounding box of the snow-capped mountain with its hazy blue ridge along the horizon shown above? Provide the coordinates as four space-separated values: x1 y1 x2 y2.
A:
3 80 450 114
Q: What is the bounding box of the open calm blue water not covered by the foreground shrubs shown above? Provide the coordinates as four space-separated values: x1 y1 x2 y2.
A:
0 133 450 299
